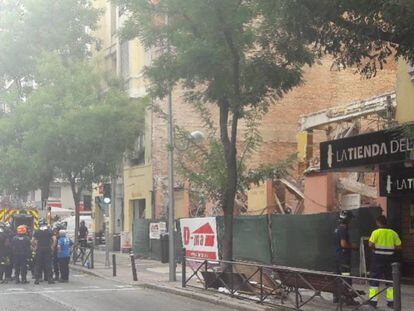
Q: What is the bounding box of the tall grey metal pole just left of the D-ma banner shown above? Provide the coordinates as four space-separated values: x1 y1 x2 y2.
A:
167 89 176 282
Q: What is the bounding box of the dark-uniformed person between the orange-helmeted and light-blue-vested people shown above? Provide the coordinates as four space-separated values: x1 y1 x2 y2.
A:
33 219 55 285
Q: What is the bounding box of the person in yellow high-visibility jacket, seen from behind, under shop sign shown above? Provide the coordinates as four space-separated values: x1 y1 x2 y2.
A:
369 215 401 308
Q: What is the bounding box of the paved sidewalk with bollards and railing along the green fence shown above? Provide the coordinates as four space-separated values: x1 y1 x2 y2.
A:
71 250 414 311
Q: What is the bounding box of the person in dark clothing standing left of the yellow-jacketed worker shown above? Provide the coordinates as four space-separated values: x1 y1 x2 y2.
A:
333 211 358 306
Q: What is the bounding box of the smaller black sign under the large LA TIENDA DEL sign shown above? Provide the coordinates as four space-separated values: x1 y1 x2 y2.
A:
380 165 414 197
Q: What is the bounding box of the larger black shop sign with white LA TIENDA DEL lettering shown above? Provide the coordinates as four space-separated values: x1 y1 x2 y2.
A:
320 128 414 171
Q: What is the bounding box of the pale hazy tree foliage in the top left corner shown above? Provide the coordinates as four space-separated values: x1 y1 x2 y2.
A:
0 0 100 97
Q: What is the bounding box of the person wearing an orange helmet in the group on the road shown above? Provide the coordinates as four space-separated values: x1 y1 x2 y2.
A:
12 225 32 284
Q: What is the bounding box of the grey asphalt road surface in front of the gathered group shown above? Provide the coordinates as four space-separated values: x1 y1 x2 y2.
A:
0 272 230 311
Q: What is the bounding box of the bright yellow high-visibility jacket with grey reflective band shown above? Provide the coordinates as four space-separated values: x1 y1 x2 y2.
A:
369 228 401 255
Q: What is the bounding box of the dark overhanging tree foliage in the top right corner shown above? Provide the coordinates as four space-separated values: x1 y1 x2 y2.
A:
259 0 414 77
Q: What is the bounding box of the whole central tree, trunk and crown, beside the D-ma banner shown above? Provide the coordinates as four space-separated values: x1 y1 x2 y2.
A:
117 0 316 260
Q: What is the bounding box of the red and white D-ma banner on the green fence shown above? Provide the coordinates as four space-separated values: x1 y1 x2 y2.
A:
180 217 218 260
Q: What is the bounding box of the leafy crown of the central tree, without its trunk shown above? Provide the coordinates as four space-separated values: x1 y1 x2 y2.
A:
117 0 313 114
